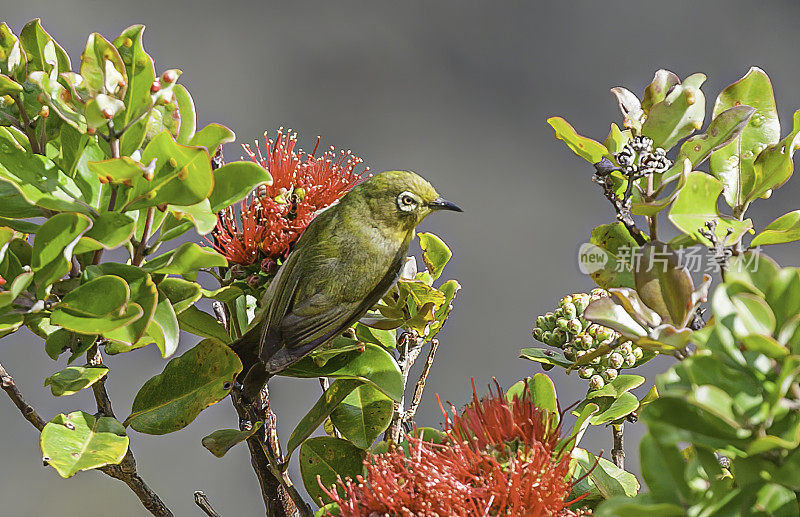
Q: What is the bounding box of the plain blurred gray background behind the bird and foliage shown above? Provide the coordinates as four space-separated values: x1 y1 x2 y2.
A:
0 0 800 517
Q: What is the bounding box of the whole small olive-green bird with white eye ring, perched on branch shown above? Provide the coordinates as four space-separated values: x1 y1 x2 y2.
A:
231 171 462 398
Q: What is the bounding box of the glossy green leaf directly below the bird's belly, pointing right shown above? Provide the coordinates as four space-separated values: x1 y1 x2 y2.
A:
279 343 403 402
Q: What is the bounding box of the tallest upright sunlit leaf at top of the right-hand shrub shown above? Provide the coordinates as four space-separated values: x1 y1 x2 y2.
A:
709 67 780 208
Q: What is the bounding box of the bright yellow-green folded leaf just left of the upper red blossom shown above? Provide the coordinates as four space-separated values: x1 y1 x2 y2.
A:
125 131 214 211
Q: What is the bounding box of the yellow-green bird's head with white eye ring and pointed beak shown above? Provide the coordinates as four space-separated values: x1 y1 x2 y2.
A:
346 171 462 231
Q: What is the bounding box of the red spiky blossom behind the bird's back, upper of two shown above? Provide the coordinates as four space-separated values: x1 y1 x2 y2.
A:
210 128 369 270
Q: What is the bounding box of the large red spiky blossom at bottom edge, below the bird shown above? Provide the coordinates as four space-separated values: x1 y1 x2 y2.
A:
323 378 591 517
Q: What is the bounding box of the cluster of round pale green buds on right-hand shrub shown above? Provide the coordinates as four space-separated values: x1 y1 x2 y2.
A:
533 289 644 390
